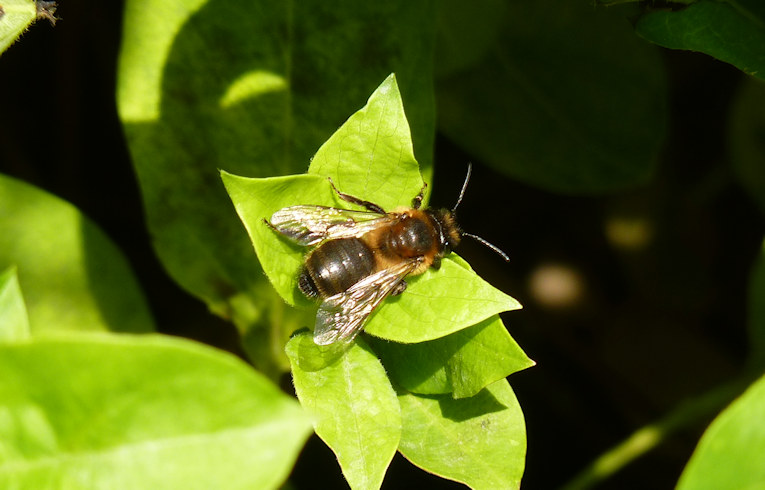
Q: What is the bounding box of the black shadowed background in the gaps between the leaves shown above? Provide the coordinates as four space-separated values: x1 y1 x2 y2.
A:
0 2 765 489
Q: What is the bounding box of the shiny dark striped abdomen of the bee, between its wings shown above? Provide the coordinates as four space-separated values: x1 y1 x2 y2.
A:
298 238 375 297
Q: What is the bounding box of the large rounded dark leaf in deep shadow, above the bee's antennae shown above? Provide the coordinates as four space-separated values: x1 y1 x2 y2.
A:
437 0 666 193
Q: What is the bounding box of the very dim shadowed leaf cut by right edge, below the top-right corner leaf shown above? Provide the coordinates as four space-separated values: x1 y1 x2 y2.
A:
728 78 765 213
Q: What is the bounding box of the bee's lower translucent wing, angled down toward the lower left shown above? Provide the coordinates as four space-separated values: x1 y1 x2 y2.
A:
313 258 422 345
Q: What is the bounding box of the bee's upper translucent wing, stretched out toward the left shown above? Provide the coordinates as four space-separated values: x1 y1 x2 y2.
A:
270 206 394 246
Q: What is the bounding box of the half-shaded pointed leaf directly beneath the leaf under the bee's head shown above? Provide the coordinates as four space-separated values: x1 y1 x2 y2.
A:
370 316 534 398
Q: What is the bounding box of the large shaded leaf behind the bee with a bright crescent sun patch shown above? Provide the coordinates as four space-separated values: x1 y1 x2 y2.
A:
117 0 434 366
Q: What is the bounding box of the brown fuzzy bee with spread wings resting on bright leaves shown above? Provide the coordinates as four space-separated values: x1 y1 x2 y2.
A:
263 166 509 345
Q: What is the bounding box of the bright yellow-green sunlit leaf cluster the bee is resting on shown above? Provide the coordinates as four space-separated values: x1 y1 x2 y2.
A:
222 76 533 488
